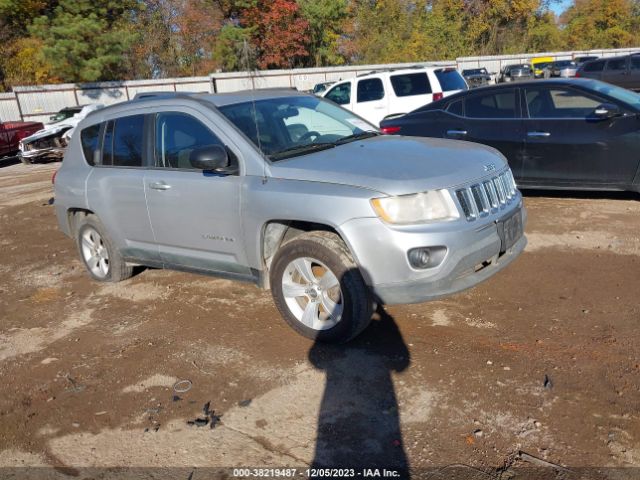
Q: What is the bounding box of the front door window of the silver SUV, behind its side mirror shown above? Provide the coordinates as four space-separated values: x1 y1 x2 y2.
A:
155 112 224 169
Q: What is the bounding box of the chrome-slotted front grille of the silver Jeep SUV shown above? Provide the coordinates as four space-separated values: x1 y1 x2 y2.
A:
456 170 517 221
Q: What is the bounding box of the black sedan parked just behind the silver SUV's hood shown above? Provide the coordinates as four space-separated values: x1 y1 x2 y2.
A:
380 79 640 192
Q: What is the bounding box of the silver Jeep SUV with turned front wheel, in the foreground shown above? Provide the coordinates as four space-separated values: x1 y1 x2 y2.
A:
55 90 526 342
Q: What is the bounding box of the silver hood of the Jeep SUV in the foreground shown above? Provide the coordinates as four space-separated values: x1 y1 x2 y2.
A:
271 135 506 195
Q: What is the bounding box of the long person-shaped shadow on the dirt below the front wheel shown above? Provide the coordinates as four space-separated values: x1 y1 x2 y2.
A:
309 307 411 478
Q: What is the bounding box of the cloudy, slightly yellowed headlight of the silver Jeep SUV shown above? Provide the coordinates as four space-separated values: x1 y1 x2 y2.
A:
371 190 460 225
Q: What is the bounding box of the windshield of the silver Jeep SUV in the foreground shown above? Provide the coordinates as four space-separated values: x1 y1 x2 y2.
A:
219 96 379 161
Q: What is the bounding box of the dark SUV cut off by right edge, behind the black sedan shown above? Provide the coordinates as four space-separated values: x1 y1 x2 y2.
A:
576 53 640 91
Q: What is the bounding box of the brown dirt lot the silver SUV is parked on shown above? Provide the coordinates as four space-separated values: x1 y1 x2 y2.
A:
0 164 640 479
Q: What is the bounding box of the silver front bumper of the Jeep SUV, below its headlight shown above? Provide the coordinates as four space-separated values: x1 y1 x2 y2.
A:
341 202 527 305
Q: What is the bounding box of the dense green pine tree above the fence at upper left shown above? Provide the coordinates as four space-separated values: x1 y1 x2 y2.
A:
29 0 138 82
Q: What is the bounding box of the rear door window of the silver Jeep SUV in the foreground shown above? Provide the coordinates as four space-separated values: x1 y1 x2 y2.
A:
102 115 144 167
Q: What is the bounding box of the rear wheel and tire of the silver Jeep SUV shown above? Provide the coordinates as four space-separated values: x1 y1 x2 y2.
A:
76 214 133 282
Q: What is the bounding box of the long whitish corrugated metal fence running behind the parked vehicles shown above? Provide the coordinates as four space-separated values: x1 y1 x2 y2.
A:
0 47 640 122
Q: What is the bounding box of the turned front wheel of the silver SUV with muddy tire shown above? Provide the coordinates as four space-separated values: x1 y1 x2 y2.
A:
269 231 373 343
